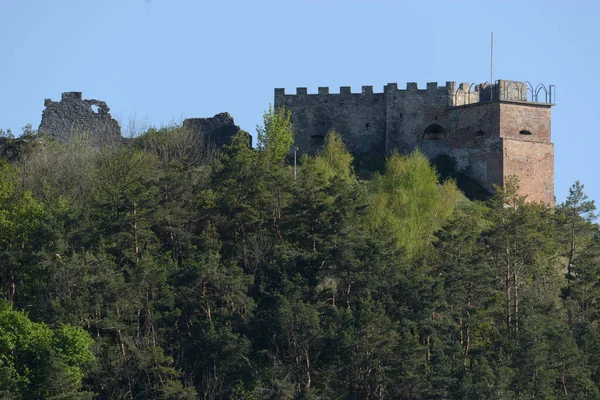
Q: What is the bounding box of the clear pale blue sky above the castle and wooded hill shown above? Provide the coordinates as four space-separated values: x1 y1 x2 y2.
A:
0 0 600 201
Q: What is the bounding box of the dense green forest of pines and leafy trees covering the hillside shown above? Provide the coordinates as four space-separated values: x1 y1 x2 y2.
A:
0 110 600 400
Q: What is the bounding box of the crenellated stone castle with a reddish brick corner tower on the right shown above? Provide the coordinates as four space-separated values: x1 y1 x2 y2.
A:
274 80 554 205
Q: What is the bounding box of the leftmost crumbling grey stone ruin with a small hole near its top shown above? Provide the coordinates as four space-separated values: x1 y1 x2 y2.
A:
39 92 122 147
